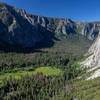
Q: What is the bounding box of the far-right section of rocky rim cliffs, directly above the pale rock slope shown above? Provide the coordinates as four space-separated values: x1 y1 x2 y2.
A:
76 22 100 40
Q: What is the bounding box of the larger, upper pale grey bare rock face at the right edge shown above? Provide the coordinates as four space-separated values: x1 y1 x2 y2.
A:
82 32 100 67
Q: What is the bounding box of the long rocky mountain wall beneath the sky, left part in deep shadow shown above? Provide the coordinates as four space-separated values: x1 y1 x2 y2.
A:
0 3 100 47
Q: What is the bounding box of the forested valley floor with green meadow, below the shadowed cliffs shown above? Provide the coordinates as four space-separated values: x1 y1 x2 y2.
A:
0 35 97 100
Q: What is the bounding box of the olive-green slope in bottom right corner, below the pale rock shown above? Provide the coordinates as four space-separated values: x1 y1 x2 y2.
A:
55 74 100 100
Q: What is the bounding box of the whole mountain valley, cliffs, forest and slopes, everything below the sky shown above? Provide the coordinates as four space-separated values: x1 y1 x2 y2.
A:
0 2 100 100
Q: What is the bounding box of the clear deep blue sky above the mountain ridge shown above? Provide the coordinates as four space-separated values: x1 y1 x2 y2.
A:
0 0 100 22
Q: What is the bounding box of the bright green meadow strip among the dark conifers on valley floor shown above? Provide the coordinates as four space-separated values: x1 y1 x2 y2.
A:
0 67 62 84
